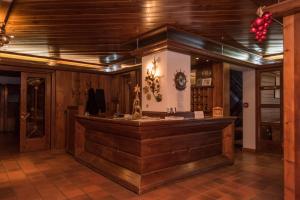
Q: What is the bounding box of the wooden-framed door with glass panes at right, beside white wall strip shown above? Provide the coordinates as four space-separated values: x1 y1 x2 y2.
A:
257 68 283 153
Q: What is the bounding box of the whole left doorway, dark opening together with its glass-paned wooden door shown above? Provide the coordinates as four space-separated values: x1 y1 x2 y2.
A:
0 71 51 155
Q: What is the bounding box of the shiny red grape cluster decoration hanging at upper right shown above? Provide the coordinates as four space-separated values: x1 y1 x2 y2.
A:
250 12 272 43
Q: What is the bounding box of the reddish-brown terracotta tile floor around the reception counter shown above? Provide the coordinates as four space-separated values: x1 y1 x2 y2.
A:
0 152 283 200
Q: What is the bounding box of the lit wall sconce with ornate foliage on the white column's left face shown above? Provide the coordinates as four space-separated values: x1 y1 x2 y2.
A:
143 58 162 102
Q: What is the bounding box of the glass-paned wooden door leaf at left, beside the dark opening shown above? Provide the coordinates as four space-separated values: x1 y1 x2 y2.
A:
20 72 51 152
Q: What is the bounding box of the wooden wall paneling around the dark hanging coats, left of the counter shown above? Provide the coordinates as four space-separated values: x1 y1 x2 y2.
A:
53 70 111 149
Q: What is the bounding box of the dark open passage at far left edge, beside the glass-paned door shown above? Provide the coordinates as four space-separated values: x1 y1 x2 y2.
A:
0 71 21 153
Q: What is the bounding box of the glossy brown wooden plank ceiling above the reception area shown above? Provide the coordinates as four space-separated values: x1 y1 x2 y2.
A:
0 0 283 63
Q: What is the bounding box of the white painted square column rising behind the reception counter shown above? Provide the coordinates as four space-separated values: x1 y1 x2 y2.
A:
142 50 191 112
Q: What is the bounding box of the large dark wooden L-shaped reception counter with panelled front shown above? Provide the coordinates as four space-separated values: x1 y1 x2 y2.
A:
75 116 235 193
